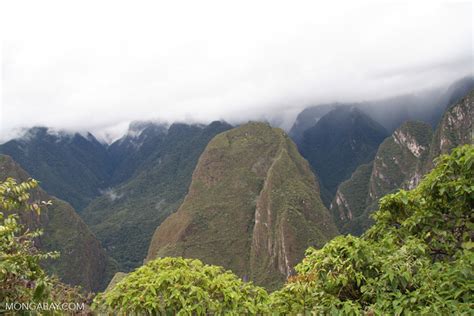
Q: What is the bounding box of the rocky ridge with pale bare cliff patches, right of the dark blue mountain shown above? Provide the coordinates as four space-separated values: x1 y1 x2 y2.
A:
330 122 432 235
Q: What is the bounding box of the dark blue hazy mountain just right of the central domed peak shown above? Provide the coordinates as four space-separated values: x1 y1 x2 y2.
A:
299 106 387 196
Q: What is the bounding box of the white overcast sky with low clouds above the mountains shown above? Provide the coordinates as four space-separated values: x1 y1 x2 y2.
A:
0 0 473 140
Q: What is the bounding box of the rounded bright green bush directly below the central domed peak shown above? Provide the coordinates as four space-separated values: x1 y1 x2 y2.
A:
93 257 268 315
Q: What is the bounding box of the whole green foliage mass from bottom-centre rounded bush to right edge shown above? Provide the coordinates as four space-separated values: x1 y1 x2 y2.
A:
94 146 474 315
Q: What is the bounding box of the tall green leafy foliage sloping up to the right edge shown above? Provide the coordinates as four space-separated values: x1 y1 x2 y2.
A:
270 145 474 315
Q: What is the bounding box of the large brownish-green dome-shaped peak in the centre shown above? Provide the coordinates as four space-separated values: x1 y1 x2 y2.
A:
147 123 338 288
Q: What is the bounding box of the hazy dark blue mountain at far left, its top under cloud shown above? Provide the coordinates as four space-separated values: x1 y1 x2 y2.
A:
0 127 110 211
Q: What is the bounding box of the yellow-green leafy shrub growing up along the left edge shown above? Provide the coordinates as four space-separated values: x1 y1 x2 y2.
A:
0 178 86 312
